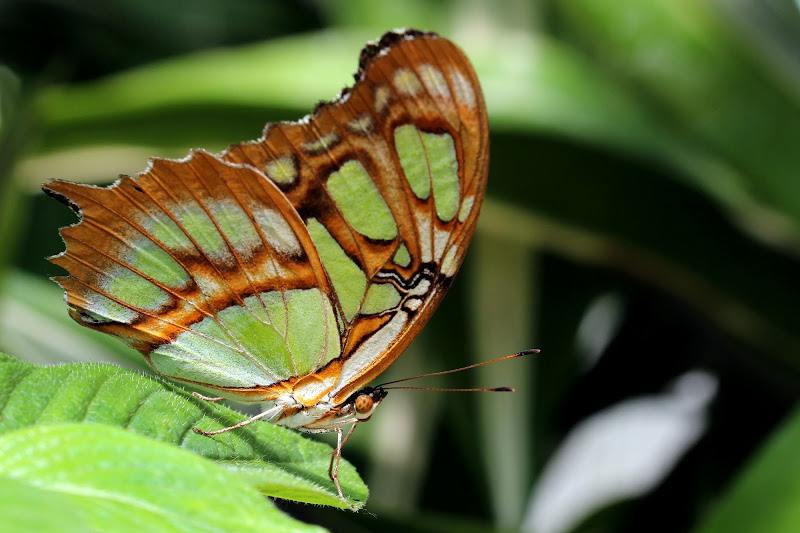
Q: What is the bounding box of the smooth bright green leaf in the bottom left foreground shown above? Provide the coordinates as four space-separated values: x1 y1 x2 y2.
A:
0 424 328 533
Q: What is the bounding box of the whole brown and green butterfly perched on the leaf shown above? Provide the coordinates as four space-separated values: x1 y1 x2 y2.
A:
43 30 489 499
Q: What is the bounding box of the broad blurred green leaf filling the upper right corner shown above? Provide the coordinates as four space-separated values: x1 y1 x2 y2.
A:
557 0 800 235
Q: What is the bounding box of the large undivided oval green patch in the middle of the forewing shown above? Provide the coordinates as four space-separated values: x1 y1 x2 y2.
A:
327 160 397 240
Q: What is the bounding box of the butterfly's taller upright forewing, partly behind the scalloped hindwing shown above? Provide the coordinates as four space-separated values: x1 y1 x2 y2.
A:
223 30 489 403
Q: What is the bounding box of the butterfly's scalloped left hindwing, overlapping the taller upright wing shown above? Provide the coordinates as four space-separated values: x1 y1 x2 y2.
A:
44 151 341 399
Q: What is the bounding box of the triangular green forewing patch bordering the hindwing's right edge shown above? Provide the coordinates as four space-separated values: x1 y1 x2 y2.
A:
307 218 367 322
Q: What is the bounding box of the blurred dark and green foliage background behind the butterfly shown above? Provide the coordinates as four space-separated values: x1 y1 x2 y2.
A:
0 0 800 533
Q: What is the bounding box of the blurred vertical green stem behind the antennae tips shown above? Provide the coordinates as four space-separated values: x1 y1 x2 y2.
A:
470 234 539 529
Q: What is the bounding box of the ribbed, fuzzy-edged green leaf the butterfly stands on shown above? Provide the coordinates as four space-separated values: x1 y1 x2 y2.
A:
0 354 368 508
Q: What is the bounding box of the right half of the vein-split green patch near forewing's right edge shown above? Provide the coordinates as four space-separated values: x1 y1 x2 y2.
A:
422 133 460 222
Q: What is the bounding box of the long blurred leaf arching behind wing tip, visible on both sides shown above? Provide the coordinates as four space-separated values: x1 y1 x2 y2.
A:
26 31 669 165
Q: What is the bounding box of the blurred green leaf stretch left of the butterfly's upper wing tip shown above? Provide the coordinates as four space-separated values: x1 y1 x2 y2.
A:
31 32 368 149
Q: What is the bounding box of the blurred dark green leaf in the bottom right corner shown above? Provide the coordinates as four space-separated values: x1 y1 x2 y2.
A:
697 409 800 533
